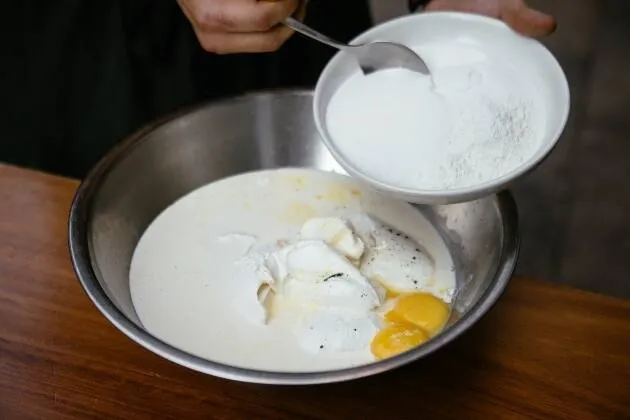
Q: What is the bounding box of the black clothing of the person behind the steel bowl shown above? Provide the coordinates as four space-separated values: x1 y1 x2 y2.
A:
0 0 370 177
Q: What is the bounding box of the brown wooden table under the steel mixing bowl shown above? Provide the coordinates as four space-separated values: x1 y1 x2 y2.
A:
0 165 630 420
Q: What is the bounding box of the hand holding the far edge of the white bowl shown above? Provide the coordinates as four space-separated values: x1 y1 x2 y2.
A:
425 0 556 37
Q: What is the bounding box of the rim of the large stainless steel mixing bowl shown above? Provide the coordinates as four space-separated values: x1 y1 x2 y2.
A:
68 89 520 385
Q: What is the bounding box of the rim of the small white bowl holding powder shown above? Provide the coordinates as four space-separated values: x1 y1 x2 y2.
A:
313 11 571 204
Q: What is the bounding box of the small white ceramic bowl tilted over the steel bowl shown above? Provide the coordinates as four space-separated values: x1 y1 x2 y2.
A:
313 12 570 204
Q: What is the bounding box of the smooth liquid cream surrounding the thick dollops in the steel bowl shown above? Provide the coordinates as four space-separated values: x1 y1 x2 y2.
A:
130 169 455 372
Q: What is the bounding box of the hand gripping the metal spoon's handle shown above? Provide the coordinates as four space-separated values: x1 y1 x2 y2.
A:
177 0 302 54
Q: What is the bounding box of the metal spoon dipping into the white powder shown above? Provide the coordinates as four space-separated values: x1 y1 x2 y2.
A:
284 18 429 75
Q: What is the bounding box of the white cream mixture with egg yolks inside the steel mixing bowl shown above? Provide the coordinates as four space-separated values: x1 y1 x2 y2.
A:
130 169 455 372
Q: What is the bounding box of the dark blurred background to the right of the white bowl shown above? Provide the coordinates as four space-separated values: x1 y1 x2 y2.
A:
514 0 630 298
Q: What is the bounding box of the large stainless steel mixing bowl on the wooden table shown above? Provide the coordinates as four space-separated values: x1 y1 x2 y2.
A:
69 91 518 384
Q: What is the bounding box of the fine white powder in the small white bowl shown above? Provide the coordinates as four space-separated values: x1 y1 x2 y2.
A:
326 46 544 190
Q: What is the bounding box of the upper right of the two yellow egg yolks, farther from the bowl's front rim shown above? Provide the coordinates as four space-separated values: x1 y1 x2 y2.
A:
391 293 450 336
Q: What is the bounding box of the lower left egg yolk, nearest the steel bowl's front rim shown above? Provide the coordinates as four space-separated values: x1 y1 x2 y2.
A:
371 325 429 359
